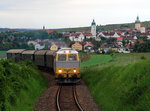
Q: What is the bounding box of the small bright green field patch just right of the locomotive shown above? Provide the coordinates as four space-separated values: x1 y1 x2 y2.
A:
81 54 112 67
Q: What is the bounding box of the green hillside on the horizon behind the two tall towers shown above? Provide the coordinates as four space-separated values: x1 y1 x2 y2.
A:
56 21 150 32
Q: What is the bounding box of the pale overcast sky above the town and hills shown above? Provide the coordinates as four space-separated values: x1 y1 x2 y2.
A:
0 0 150 29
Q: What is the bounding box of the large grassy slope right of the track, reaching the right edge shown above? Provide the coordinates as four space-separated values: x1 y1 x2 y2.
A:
81 53 150 111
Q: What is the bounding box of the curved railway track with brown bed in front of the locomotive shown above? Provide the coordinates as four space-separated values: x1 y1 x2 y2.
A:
56 85 83 111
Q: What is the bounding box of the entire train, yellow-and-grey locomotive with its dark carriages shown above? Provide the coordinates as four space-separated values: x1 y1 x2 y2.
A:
7 48 80 83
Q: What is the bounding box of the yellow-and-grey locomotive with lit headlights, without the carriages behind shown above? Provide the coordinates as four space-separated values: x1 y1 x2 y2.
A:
54 48 80 83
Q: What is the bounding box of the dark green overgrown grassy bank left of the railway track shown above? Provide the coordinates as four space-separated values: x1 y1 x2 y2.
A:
0 60 47 111
